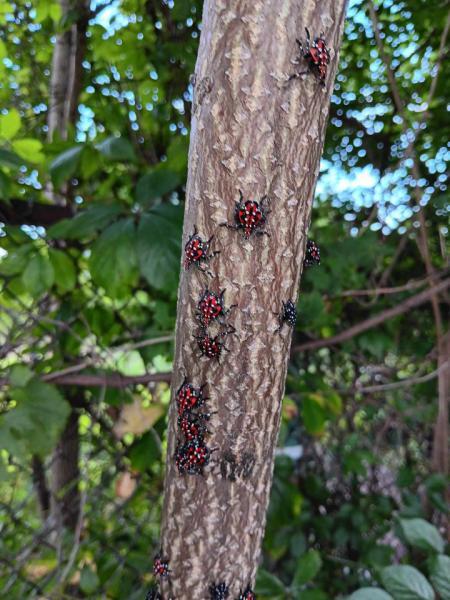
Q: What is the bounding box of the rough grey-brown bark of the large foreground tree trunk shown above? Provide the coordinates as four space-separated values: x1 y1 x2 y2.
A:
161 0 346 600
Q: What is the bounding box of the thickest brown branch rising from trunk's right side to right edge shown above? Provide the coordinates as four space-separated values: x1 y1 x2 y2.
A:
292 278 450 352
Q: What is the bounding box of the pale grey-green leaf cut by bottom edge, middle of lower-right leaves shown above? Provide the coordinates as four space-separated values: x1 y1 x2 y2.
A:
381 565 435 600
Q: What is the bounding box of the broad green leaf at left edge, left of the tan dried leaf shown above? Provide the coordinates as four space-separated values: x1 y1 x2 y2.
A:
0 379 70 458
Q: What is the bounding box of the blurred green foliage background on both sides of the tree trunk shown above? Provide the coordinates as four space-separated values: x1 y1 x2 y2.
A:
0 0 450 600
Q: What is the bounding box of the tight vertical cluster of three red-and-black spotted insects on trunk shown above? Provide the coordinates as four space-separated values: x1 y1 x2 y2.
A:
175 379 212 475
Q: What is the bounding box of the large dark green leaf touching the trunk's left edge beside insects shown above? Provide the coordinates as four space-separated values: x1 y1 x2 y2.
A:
137 204 183 291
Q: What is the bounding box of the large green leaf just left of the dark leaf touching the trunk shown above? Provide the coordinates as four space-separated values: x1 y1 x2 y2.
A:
89 219 137 297
